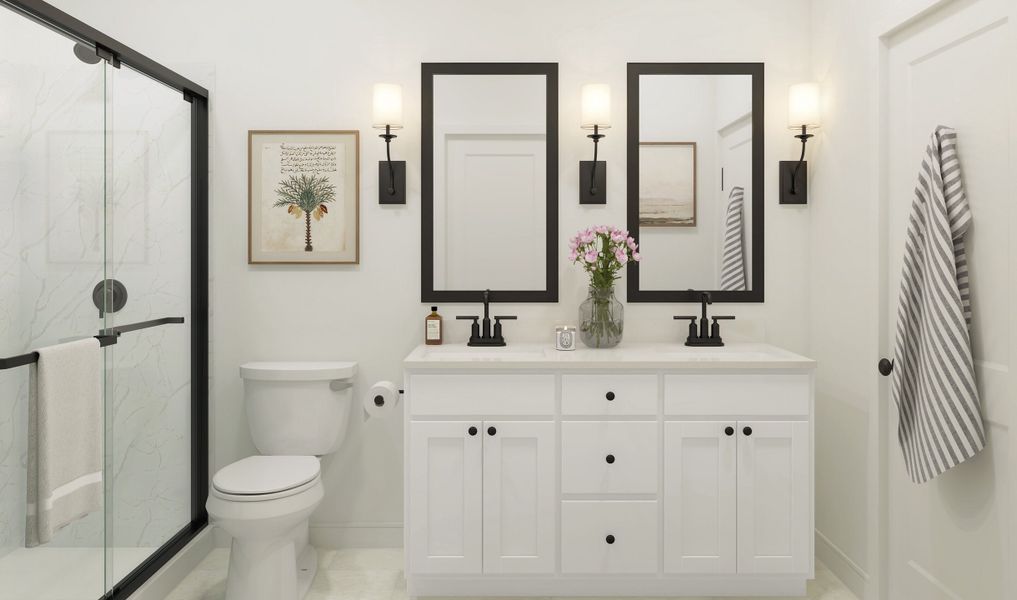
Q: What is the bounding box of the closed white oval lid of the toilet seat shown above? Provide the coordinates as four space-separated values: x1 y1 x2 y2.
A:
212 457 320 495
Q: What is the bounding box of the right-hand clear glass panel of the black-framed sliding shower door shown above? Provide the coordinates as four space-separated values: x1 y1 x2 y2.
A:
106 65 191 582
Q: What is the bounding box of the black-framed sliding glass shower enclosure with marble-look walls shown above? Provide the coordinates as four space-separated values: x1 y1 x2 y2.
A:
0 0 208 600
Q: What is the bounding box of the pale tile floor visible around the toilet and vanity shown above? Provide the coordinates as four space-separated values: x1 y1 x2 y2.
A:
166 548 857 600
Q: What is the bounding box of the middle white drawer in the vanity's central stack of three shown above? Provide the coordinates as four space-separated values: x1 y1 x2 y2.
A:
561 421 659 493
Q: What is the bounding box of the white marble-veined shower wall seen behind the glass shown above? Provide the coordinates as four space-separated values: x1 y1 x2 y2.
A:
0 49 190 554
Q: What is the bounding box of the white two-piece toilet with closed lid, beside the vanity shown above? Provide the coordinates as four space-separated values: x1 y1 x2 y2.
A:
205 362 357 600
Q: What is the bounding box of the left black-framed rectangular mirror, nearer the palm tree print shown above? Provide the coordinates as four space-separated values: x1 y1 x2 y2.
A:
420 63 558 302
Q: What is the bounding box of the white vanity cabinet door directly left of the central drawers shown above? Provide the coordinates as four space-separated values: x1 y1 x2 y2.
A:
482 421 557 574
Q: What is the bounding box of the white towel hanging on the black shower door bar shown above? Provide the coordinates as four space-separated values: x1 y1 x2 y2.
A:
25 338 103 547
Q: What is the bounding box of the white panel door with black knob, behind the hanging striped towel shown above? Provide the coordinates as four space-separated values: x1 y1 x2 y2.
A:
871 0 1017 600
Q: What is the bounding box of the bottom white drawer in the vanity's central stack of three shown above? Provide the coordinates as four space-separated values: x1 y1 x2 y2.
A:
561 500 658 575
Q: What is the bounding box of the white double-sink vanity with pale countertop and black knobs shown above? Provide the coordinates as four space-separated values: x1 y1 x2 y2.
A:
404 344 814 597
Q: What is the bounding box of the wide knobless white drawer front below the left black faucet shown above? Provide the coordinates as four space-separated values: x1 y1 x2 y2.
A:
407 373 554 417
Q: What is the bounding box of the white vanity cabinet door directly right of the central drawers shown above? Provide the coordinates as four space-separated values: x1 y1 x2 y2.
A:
664 421 738 574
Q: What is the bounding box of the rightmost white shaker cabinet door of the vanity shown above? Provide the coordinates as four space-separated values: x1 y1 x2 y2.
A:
736 421 813 574
